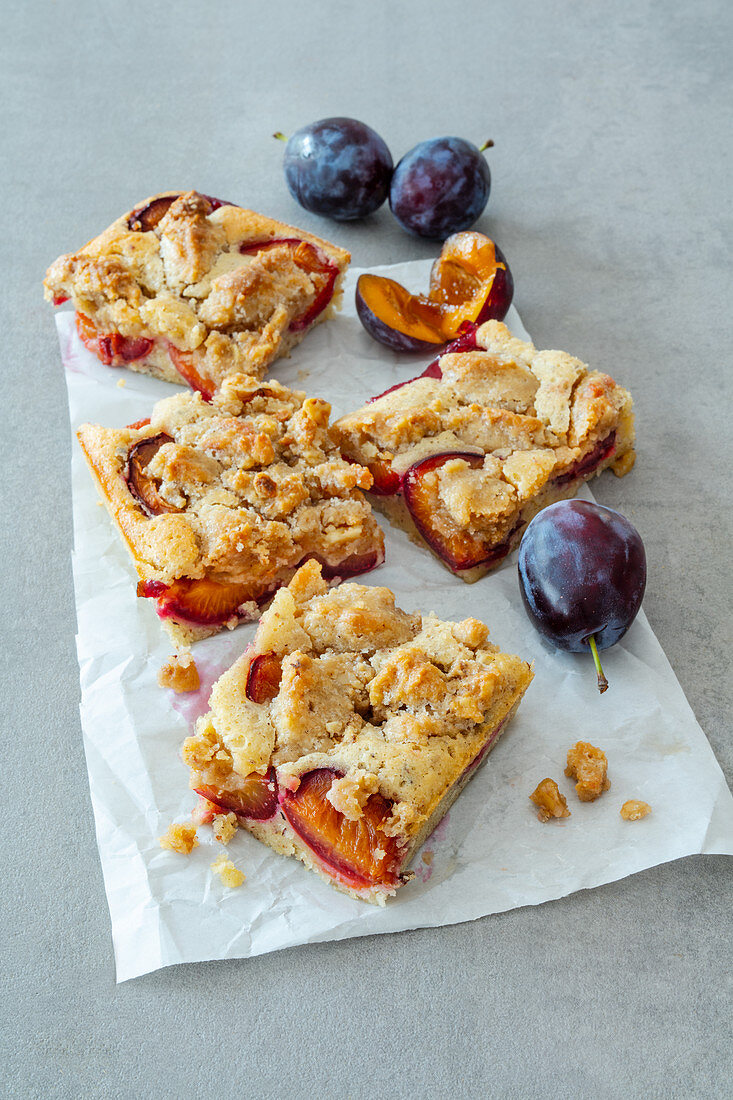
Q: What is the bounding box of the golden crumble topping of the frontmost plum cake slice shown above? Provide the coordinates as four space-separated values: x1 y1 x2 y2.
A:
183 561 532 836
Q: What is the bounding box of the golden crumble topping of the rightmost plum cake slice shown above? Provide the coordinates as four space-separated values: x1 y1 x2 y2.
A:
333 321 634 563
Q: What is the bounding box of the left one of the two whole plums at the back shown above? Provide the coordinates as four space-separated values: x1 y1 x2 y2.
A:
284 119 393 221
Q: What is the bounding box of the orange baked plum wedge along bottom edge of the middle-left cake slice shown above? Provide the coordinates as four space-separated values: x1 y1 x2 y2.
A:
138 576 263 626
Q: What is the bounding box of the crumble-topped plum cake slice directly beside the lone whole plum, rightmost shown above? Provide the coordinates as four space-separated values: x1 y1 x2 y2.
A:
332 321 634 582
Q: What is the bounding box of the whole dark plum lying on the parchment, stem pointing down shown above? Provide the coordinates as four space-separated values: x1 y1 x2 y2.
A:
517 501 646 653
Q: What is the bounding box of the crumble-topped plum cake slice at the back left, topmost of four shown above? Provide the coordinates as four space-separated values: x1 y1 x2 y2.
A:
44 191 350 397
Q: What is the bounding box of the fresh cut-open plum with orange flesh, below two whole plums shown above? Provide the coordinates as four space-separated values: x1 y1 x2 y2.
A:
355 231 514 352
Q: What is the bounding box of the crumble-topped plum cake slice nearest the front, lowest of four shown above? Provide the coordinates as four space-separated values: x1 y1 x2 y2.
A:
183 561 532 904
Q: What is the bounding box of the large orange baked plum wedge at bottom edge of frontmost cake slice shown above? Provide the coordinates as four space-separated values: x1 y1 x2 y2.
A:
280 768 401 889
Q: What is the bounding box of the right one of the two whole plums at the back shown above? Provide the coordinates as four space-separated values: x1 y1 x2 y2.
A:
390 138 491 241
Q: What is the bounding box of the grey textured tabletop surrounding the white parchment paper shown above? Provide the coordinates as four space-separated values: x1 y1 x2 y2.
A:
0 0 733 1100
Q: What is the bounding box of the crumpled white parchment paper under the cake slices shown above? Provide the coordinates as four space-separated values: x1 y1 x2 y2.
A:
57 261 733 981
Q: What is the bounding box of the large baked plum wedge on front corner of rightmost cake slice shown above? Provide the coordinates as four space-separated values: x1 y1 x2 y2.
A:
402 451 513 572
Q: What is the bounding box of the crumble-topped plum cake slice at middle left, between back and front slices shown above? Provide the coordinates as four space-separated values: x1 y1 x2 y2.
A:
77 375 384 645
